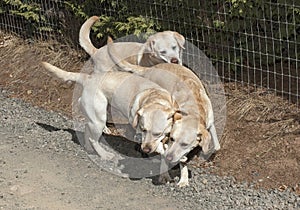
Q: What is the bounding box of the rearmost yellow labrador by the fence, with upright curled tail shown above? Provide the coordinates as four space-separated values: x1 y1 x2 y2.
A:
79 16 185 72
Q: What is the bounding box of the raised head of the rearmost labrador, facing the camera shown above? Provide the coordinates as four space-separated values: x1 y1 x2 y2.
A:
138 31 185 65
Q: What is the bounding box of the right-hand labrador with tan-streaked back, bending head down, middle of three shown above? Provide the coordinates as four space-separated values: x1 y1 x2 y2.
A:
108 44 220 187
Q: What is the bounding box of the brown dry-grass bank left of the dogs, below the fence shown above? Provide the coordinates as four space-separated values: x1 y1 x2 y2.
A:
0 32 86 115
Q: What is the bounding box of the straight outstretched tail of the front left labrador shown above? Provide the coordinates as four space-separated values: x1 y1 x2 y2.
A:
42 62 88 85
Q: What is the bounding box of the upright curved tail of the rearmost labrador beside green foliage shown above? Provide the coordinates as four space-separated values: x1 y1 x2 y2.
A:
79 16 99 56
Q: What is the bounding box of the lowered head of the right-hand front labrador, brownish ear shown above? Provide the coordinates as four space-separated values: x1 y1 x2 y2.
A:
165 116 211 163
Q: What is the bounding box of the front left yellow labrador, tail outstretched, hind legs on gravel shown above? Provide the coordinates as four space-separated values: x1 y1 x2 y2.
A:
42 62 176 164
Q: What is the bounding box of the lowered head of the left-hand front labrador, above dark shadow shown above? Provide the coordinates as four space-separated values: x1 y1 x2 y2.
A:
133 104 176 153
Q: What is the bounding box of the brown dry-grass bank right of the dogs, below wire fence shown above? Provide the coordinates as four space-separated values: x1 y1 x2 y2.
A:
214 84 300 191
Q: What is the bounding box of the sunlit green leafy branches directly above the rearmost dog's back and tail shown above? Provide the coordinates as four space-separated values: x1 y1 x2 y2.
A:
65 0 159 38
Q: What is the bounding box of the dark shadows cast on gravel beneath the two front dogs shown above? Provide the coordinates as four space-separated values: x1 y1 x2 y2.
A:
36 122 180 185
